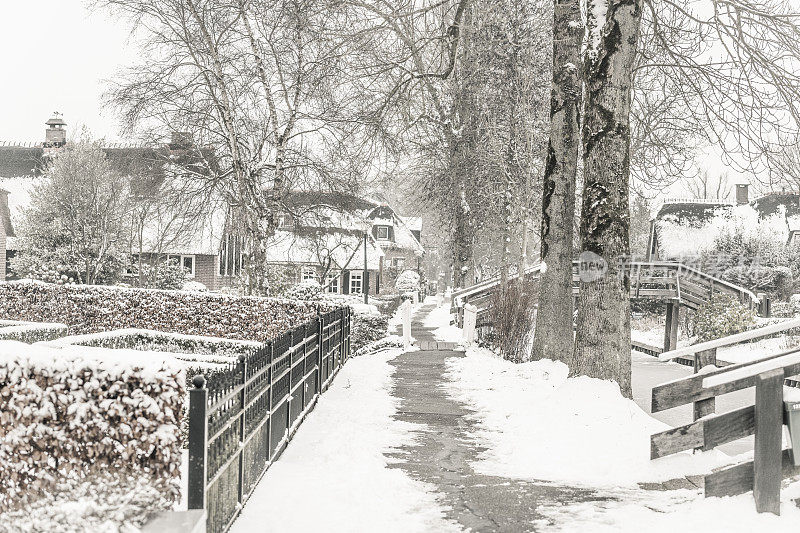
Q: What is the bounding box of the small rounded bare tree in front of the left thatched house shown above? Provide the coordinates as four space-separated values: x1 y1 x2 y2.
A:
14 140 130 284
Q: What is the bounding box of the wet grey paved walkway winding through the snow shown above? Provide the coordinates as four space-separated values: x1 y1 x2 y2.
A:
384 305 606 532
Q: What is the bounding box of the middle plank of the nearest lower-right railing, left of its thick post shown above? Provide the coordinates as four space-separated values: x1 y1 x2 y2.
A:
650 405 755 459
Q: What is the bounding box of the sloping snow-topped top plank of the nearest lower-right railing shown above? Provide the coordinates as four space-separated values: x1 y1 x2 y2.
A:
651 348 800 413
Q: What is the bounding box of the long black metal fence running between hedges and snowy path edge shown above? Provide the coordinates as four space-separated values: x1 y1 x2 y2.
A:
188 307 351 533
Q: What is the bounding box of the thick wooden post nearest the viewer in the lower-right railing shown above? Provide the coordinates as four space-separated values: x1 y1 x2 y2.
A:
753 368 783 515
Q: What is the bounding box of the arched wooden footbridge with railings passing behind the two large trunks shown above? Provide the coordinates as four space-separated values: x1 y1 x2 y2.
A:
452 261 769 355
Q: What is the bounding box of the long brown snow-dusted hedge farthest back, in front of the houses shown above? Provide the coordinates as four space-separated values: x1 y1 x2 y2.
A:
0 282 333 342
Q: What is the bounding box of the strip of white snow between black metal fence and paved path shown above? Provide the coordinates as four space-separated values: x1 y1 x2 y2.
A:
231 349 459 533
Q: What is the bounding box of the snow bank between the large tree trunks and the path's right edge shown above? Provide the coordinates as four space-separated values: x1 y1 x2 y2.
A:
447 348 730 486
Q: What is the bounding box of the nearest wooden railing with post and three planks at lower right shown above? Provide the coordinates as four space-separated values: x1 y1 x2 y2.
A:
650 349 800 514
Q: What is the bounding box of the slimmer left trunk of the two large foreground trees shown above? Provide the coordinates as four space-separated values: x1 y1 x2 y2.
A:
531 0 583 361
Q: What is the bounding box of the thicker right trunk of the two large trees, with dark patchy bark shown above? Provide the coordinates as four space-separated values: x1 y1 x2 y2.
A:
570 0 641 397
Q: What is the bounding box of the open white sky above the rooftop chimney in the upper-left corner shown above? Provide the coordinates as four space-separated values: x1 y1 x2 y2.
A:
0 0 135 142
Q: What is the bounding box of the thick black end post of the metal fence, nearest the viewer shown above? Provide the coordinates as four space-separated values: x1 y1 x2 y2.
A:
186 374 208 509
